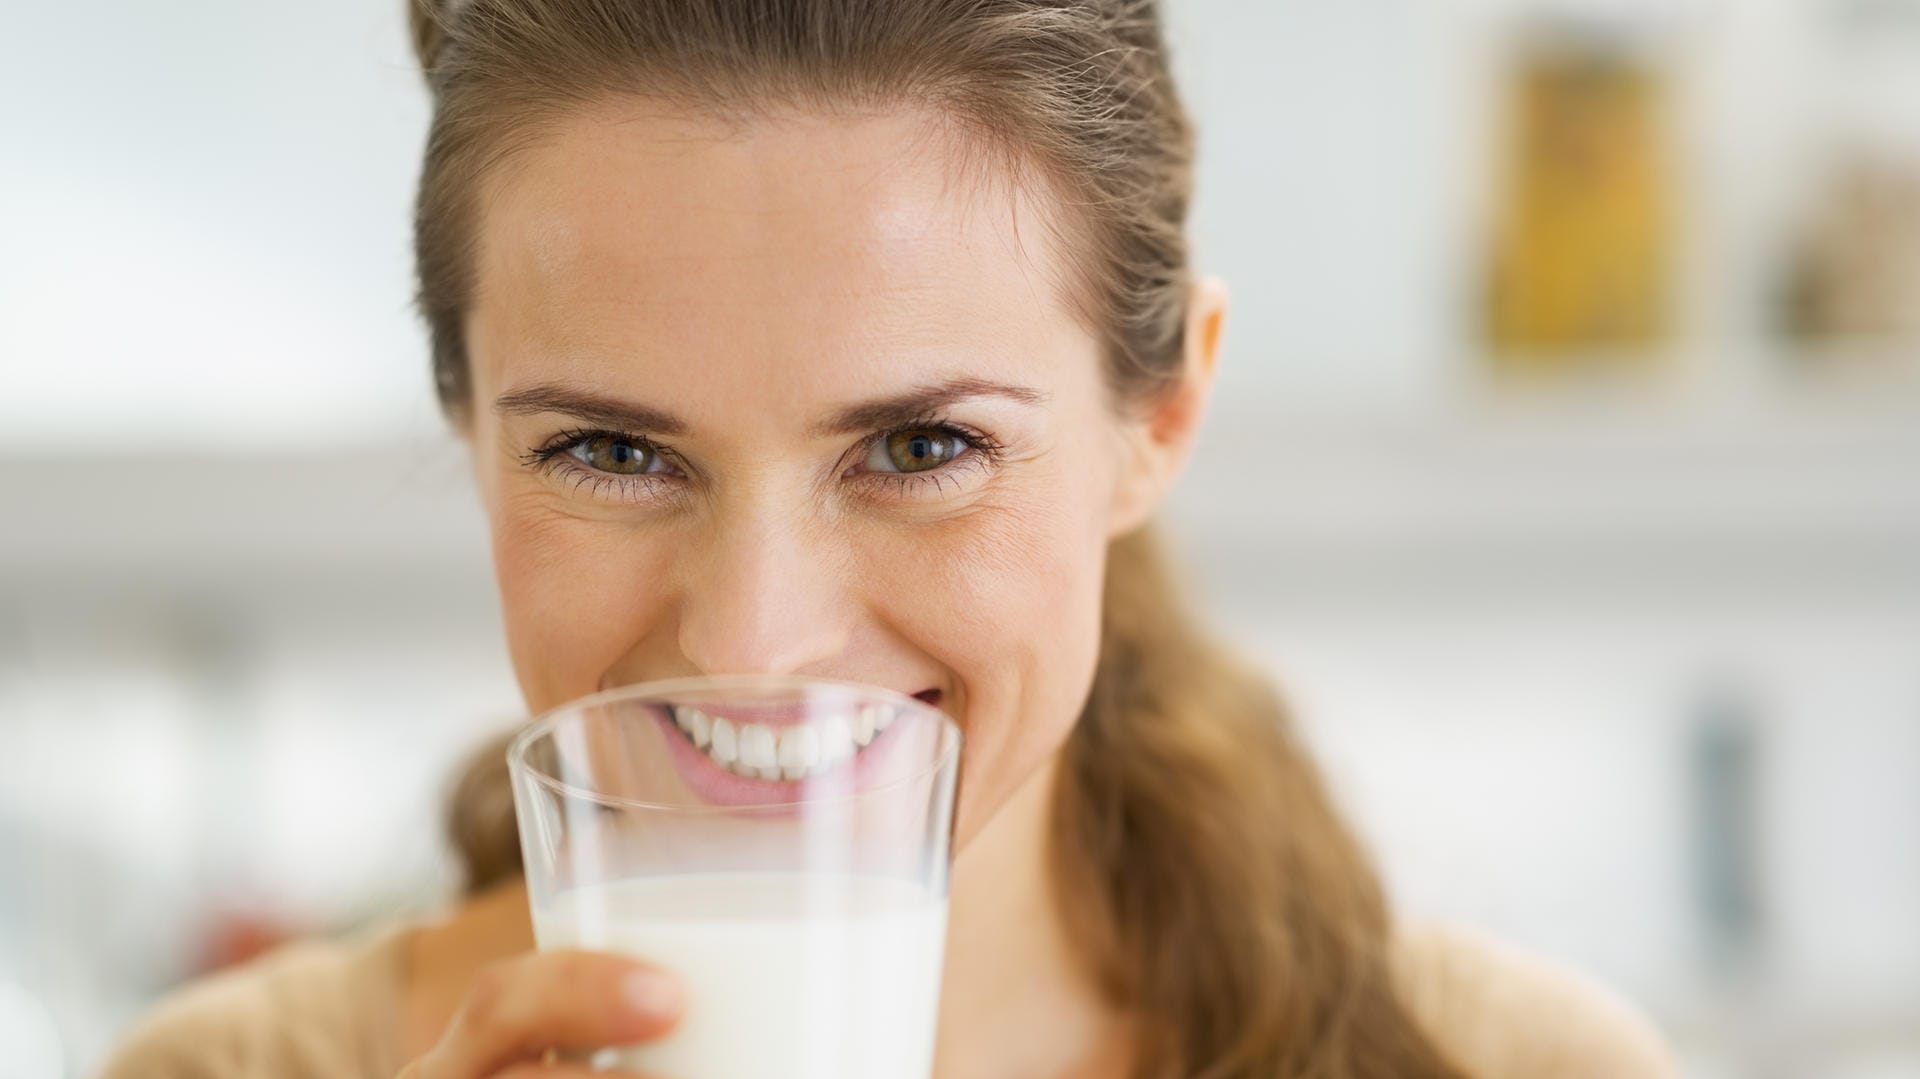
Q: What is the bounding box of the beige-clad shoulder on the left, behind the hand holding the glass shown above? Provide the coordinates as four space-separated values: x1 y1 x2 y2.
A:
98 929 399 1079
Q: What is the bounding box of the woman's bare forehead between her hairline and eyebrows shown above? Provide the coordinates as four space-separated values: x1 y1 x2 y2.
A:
470 102 1085 399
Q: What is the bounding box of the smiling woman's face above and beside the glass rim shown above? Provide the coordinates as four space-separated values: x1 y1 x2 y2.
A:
467 104 1205 841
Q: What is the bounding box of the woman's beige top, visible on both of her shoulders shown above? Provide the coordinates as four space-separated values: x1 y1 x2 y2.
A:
100 913 1678 1079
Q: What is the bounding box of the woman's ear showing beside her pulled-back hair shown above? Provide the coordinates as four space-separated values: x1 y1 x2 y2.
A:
1108 276 1227 536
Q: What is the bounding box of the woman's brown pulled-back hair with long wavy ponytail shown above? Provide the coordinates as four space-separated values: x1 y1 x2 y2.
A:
413 0 1459 1079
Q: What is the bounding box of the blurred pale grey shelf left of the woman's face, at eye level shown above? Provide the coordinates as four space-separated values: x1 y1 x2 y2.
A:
0 440 492 599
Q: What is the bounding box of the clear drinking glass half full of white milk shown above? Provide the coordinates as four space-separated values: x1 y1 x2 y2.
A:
507 676 960 1079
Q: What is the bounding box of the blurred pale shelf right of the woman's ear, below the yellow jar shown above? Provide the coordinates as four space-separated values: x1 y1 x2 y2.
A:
1171 388 1920 601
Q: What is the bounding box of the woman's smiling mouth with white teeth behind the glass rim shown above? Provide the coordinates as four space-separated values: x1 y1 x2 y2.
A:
670 689 941 783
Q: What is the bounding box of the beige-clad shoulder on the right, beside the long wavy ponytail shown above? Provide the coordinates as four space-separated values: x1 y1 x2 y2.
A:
1394 913 1680 1079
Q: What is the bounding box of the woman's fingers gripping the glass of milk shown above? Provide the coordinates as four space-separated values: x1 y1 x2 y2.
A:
399 950 684 1079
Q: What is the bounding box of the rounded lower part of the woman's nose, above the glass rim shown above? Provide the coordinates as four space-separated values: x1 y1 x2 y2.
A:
680 503 851 674
